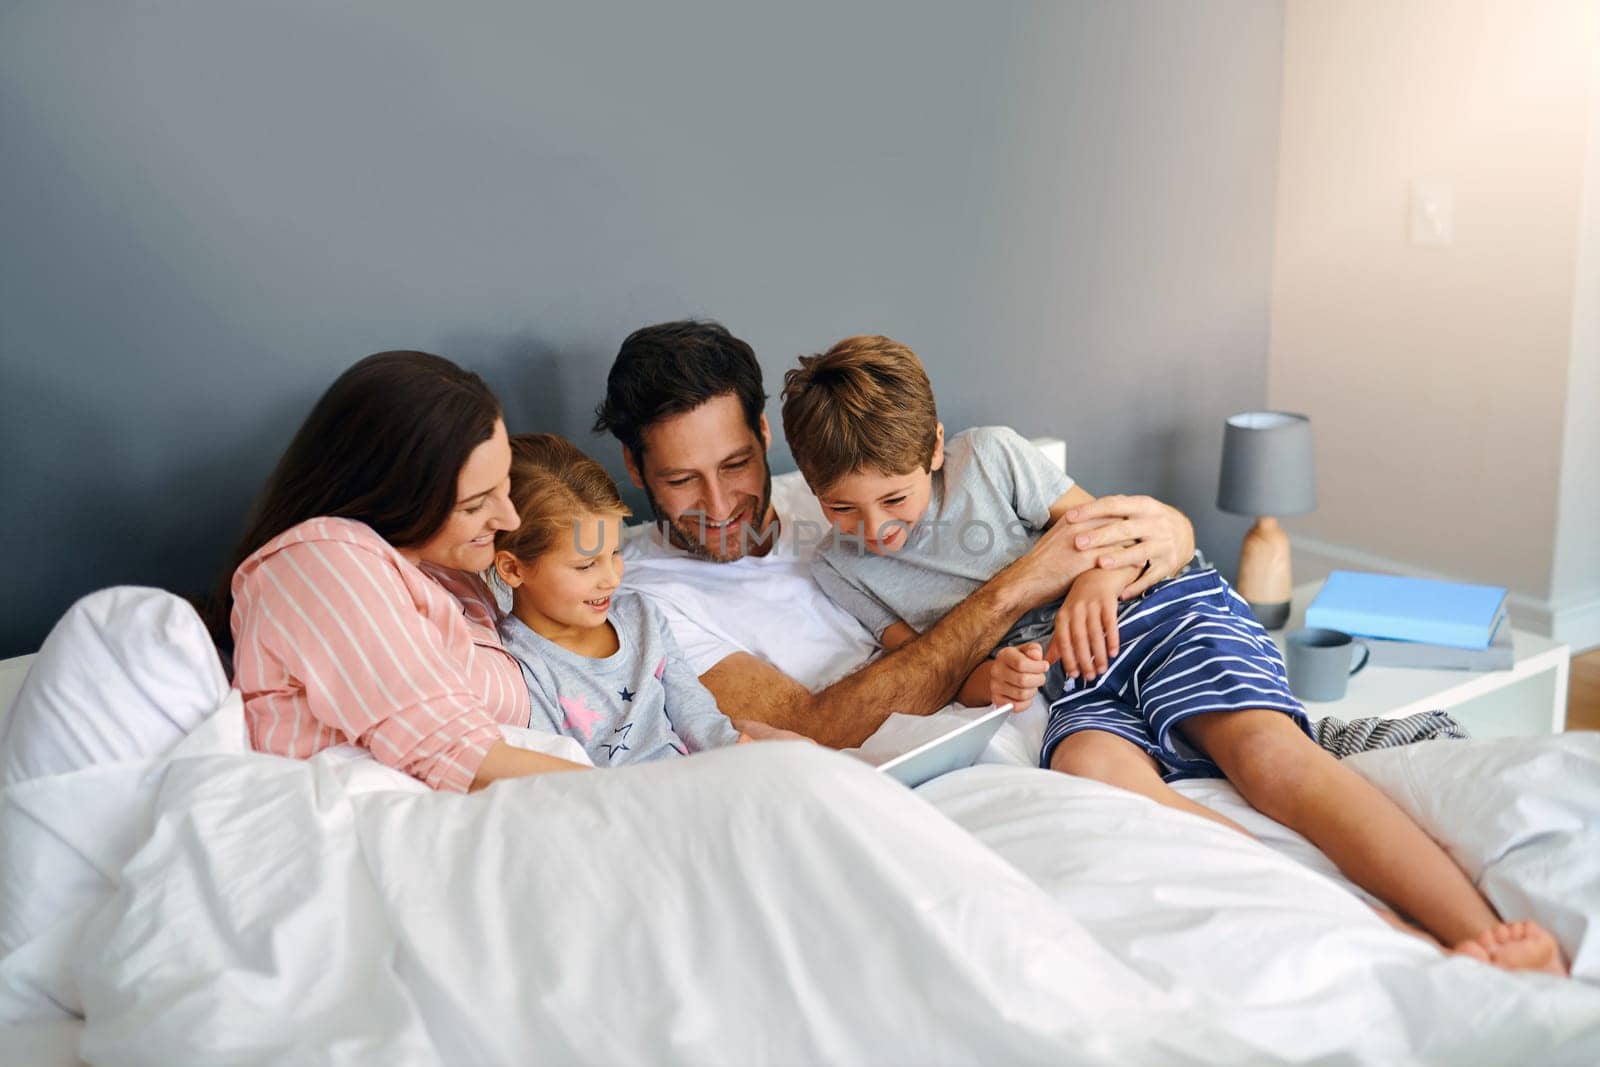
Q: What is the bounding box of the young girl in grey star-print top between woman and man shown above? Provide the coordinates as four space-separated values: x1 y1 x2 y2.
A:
494 434 758 766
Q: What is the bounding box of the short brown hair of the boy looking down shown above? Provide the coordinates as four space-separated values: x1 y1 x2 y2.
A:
784 334 939 493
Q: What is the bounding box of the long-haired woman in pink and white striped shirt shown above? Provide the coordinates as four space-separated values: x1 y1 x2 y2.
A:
211 352 584 792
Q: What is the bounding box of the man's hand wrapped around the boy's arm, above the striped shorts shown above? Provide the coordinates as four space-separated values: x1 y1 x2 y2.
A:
1062 496 1195 601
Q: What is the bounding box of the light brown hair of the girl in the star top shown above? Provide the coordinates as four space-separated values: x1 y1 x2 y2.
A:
494 434 632 560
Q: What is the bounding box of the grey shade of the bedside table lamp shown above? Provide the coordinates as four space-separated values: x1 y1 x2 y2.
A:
1216 411 1317 517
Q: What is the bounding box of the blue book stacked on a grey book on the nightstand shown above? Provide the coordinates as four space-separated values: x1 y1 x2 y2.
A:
1306 571 1515 670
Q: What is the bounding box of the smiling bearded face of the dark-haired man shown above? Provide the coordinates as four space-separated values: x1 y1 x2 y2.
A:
622 394 774 563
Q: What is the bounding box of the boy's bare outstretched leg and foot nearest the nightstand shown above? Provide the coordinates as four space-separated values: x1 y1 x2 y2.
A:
1179 710 1566 974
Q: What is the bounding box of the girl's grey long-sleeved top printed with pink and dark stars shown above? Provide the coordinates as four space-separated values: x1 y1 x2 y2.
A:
499 592 739 766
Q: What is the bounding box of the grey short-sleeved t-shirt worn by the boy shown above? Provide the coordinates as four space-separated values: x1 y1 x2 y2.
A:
811 426 1074 646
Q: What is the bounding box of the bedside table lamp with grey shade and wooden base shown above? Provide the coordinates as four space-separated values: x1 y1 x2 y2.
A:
1216 411 1317 630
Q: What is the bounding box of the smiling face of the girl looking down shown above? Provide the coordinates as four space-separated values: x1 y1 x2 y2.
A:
494 514 622 641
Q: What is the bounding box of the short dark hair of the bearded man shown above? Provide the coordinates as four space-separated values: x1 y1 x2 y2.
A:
594 320 766 462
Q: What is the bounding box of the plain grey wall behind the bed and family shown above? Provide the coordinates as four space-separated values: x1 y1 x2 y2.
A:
0 0 1282 656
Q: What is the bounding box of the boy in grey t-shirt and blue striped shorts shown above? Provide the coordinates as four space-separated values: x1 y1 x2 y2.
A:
782 336 1566 974
